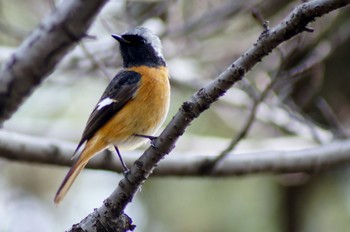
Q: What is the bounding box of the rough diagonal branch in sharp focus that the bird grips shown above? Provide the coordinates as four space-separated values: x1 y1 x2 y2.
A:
65 0 350 231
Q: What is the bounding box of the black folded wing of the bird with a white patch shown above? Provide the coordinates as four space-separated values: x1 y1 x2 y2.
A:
74 70 141 154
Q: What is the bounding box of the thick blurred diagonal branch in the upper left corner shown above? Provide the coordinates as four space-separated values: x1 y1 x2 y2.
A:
0 0 107 125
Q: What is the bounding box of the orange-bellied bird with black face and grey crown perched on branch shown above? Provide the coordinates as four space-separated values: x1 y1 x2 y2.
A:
54 27 170 204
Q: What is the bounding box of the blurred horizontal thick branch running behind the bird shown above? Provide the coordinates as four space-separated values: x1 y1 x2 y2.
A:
0 131 350 177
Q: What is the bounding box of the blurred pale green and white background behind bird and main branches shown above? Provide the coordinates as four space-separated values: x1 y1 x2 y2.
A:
0 0 350 232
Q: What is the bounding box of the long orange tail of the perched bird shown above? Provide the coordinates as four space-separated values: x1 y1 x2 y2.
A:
54 142 105 204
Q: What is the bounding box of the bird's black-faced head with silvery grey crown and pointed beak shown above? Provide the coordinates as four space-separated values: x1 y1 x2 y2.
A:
112 27 166 68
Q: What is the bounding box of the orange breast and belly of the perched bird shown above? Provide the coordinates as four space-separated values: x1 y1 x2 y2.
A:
93 66 170 149
